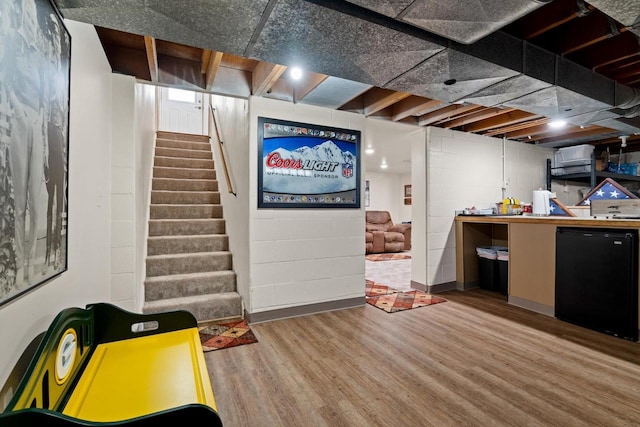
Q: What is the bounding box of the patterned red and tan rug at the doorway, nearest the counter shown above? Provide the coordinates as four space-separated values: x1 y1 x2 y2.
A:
365 280 447 313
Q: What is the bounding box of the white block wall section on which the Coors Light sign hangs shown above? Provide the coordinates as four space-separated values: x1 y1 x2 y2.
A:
245 97 365 313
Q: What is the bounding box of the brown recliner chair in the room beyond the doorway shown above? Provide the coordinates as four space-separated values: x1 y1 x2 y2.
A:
364 211 411 254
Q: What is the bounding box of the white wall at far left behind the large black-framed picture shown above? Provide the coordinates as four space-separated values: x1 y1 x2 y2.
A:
0 20 111 388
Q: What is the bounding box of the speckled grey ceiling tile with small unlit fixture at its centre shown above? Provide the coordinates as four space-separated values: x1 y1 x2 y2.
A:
385 49 518 102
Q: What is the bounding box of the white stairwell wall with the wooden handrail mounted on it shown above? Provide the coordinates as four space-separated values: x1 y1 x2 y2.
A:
209 96 255 303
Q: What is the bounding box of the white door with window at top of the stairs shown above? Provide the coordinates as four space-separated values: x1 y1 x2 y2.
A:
159 87 207 135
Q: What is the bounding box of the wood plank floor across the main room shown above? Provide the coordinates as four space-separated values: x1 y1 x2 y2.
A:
205 290 640 427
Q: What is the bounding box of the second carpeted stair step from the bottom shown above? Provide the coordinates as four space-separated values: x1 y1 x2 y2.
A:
144 270 236 301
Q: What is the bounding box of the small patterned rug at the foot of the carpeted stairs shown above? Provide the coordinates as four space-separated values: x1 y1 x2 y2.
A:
198 319 258 352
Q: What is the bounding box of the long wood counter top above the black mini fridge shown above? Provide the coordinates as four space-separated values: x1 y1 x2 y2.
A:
455 215 640 228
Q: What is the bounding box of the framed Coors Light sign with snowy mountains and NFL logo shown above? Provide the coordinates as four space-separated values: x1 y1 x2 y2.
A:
258 117 360 208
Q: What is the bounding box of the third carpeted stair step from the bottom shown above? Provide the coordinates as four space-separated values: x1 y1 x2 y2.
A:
146 251 231 277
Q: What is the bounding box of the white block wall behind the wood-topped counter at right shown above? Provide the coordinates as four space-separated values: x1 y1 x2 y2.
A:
422 128 554 285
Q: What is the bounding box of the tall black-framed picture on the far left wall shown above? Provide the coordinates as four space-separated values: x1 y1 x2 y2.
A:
0 0 71 305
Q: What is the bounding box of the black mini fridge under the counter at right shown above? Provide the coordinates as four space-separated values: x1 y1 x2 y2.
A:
555 227 638 341
